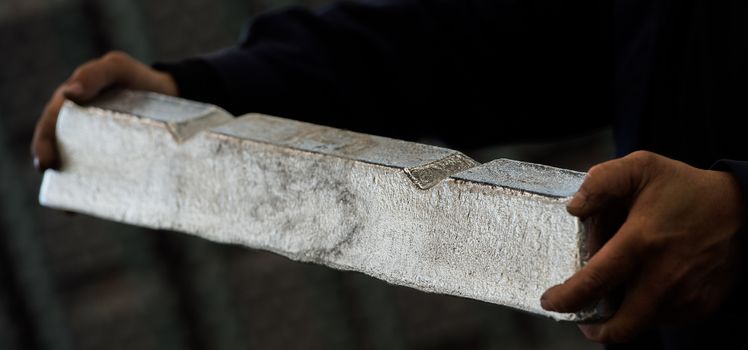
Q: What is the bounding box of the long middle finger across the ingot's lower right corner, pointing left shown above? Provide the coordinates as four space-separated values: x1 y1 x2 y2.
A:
540 223 640 312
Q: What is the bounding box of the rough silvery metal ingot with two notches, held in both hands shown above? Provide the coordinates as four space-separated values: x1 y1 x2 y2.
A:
39 91 600 321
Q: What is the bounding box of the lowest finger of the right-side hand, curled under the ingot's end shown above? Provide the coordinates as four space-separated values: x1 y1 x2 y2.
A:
579 275 662 343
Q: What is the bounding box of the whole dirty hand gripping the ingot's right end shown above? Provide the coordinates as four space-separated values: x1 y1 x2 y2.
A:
541 151 744 342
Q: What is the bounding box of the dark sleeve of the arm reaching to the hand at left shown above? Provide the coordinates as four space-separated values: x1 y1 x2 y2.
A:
155 0 611 147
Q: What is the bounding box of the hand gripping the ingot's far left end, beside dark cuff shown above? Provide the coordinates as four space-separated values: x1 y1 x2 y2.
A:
31 51 177 171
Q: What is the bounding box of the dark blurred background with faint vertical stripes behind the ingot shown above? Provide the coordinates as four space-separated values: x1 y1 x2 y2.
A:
0 0 612 350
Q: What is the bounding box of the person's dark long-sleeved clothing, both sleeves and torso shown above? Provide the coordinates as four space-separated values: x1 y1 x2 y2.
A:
156 0 748 349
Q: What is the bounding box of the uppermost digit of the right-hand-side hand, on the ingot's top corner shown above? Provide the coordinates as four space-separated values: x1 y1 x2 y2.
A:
567 152 651 218
